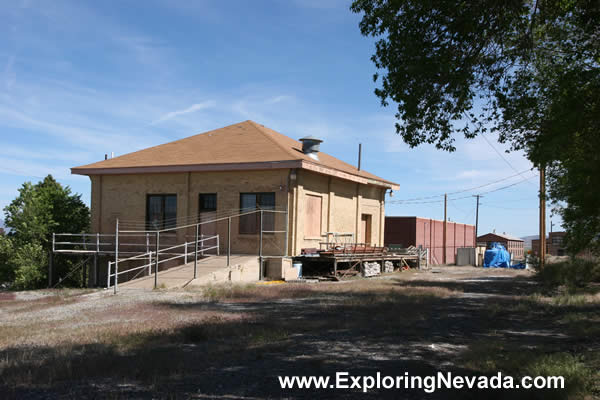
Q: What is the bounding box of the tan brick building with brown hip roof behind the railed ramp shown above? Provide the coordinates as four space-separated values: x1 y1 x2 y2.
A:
72 121 398 256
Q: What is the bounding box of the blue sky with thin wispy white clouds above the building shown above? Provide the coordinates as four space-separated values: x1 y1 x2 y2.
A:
0 0 558 236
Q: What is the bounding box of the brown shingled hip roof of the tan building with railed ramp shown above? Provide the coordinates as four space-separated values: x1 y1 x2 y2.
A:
71 121 398 188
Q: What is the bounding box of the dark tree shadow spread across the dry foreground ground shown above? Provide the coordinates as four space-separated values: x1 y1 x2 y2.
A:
0 277 598 399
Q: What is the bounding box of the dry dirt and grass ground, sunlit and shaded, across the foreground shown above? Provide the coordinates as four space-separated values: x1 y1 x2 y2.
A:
0 267 600 399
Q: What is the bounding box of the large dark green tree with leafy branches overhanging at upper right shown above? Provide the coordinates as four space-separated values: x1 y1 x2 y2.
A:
351 0 600 252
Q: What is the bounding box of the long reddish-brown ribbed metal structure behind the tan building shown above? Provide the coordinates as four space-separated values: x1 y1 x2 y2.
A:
384 217 475 265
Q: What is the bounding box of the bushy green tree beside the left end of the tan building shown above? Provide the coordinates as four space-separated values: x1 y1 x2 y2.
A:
0 175 89 288
